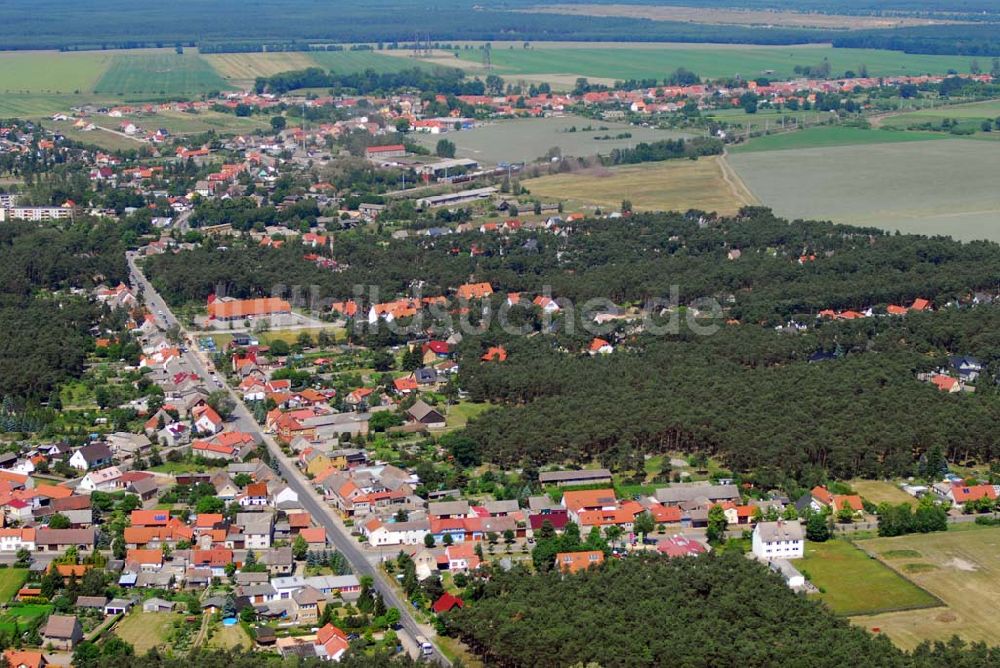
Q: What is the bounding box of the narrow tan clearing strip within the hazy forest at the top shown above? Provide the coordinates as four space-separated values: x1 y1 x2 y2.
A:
521 4 958 30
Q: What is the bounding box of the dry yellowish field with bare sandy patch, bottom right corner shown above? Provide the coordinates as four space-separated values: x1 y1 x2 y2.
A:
853 528 1000 649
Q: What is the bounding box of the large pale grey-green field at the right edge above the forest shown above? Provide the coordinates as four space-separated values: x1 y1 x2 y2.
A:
729 139 1000 240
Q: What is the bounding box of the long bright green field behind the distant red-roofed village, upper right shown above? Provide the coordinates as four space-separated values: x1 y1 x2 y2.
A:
437 42 970 86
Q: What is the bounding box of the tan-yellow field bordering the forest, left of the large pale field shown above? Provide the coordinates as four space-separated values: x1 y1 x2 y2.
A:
524 156 753 215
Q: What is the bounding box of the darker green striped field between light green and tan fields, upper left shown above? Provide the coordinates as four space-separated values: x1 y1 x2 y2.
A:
94 52 226 96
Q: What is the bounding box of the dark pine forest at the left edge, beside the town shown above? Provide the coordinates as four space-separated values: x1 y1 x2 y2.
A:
0 223 127 398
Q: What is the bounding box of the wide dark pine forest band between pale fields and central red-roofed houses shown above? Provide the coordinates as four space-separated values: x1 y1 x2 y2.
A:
147 208 1000 324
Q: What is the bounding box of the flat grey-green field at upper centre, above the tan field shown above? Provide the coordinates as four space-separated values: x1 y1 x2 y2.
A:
414 116 687 164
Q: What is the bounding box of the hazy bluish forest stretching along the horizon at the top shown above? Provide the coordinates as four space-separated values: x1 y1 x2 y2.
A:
0 0 997 54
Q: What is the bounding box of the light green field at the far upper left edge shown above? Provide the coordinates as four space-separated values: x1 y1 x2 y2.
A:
0 51 113 96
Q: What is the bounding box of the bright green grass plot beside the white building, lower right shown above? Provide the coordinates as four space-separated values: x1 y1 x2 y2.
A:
795 540 939 617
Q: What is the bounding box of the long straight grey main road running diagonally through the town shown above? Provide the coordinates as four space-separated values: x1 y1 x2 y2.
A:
128 253 451 666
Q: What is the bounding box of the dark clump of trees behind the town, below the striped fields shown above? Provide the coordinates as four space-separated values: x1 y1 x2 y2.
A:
254 67 486 95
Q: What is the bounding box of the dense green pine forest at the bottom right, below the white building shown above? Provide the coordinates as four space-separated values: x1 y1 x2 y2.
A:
445 553 998 668
